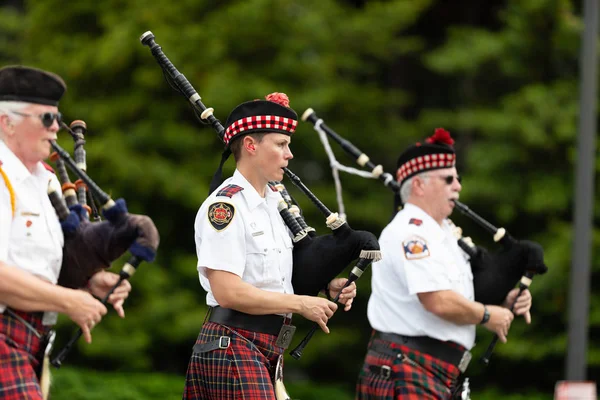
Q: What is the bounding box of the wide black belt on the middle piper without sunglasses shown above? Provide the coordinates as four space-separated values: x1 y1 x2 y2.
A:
208 306 289 335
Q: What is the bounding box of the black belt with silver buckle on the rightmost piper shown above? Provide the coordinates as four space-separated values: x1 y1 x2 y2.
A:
371 331 471 372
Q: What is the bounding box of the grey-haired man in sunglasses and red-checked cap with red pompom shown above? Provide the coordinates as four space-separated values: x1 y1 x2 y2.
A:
356 128 531 400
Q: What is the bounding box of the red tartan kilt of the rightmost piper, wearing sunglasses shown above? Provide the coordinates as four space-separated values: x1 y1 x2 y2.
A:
356 337 460 400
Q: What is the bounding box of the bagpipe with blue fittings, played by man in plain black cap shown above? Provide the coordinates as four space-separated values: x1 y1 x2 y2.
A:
48 121 159 368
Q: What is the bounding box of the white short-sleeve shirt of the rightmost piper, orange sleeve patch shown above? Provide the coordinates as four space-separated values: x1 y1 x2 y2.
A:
367 203 475 349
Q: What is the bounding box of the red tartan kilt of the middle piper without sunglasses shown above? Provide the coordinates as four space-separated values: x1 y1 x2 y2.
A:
183 322 283 400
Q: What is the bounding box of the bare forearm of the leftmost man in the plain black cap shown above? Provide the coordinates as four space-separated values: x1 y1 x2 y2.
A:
0 262 69 312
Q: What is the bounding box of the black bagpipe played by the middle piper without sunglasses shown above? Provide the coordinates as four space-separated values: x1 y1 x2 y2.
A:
140 31 381 354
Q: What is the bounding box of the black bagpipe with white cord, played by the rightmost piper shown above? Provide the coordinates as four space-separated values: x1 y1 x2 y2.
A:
302 108 548 364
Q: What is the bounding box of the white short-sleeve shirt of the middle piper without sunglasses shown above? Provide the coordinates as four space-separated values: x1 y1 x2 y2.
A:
194 170 294 307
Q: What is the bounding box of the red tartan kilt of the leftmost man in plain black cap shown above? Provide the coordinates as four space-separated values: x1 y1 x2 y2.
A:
0 310 49 400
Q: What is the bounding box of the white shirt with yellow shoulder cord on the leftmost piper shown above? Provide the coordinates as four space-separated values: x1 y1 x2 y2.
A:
0 140 64 312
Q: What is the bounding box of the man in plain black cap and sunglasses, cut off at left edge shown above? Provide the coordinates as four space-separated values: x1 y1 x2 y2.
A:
0 66 157 399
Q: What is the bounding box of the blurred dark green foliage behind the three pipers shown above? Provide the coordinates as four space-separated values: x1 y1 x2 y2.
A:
0 0 600 400
